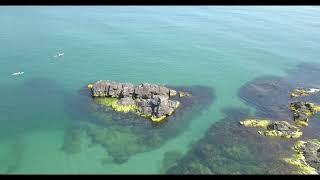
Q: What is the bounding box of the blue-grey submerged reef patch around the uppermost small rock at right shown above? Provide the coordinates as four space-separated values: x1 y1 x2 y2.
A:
238 63 320 126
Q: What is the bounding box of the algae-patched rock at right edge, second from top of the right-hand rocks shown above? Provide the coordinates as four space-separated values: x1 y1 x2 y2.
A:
289 101 320 126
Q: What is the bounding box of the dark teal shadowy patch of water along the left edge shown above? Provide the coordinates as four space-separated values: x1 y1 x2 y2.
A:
0 77 67 138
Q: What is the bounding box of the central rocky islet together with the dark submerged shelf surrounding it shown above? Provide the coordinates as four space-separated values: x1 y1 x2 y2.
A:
61 80 215 165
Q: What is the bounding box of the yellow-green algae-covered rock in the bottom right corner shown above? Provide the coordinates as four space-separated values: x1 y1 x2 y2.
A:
283 139 320 174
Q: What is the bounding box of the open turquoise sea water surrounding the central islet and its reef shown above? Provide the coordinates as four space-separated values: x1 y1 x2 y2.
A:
0 6 320 174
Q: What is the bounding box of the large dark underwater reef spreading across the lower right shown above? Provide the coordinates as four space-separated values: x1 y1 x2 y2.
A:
166 63 320 174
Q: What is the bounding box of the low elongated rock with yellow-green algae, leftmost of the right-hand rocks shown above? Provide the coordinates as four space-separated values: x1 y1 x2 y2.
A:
240 119 303 138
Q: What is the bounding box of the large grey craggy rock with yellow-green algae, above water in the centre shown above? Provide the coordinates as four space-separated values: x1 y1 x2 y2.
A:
88 80 191 122
